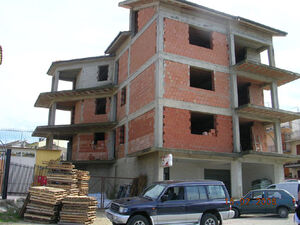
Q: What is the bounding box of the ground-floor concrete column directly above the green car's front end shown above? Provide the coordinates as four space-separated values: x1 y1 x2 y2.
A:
230 160 243 198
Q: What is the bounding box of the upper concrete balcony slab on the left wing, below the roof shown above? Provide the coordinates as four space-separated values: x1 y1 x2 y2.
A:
34 85 117 110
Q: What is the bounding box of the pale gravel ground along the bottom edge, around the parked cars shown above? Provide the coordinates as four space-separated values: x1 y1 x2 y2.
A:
1 211 295 225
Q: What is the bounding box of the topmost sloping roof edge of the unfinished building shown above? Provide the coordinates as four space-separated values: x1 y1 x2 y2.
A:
119 0 287 36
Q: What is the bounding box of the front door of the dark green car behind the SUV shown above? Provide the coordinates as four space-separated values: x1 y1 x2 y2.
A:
241 190 266 213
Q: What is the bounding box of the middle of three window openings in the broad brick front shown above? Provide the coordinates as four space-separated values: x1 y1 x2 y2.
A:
190 67 214 91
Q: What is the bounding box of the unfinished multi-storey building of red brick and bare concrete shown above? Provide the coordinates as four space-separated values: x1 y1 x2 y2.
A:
34 0 300 197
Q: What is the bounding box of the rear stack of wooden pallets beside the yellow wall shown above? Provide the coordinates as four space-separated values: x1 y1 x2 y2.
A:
47 161 79 195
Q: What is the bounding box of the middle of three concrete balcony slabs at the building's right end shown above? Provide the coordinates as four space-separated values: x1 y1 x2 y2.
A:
236 104 300 123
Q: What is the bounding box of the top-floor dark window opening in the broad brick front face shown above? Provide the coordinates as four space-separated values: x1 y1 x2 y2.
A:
189 26 212 49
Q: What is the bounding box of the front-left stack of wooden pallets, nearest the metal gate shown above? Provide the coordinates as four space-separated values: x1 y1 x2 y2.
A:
24 186 67 223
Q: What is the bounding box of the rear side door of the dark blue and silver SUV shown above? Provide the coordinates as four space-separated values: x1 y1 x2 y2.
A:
185 185 208 223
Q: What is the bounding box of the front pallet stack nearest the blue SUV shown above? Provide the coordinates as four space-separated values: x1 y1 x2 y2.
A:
58 195 97 225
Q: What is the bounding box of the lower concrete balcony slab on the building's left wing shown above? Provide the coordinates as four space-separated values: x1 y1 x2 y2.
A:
32 122 117 140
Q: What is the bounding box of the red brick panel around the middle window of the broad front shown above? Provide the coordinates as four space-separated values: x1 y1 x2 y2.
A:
164 61 230 108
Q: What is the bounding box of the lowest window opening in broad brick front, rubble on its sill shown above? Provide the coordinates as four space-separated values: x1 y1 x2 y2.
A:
191 112 216 136
